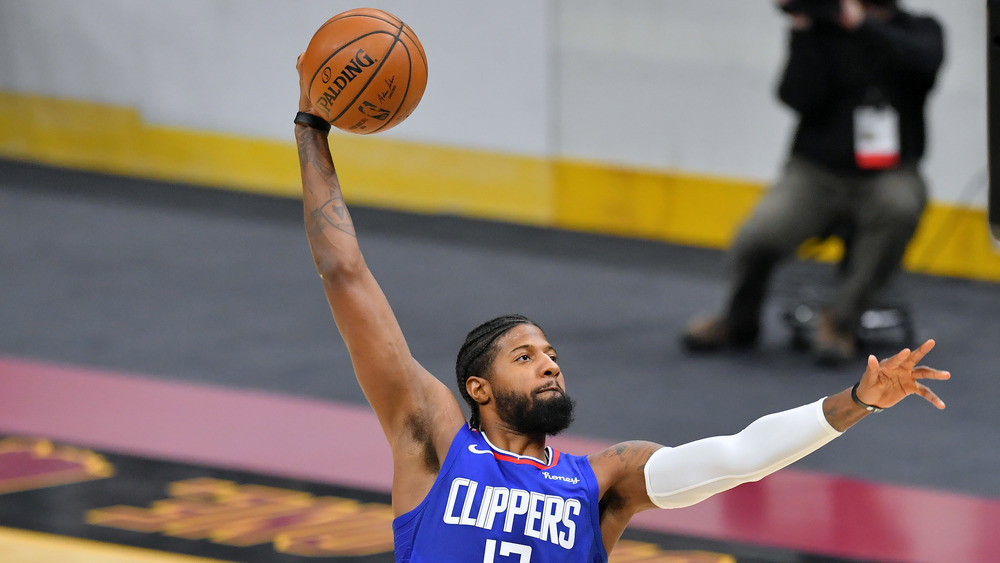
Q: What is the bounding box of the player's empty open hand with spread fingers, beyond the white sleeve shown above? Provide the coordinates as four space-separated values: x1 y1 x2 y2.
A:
857 340 951 409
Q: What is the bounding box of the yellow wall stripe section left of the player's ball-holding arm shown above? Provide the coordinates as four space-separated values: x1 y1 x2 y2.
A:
0 93 300 196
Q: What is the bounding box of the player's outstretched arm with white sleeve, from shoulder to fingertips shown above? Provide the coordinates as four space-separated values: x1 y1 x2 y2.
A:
590 340 951 545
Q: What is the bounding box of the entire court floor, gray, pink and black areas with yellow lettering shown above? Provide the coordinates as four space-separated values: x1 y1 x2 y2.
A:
0 161 1000 563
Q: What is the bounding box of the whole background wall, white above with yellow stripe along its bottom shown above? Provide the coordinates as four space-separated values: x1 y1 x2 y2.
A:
0 0 1000 279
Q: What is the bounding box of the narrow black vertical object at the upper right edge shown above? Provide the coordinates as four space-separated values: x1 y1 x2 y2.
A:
986 0 1000 241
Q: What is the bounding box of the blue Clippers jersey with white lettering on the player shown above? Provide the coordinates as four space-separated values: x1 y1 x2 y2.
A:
392 426 608 563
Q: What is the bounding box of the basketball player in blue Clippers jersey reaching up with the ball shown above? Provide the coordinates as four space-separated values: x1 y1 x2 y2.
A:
295 55 950 563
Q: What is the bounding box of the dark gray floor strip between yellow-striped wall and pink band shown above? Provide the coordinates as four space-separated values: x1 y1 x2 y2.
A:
0 161 1000 498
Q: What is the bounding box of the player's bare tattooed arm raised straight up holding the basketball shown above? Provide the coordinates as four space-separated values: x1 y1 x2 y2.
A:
295 55 465 514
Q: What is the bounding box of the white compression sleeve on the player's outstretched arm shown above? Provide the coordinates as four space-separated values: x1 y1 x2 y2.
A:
645 399 842 508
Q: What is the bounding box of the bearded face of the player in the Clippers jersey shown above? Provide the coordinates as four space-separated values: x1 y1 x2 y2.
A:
491 324 573 435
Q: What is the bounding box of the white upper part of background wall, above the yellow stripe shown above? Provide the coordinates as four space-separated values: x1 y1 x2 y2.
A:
0 0 986 207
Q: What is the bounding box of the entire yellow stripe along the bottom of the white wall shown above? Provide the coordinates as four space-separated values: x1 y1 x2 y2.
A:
0 92 1000 281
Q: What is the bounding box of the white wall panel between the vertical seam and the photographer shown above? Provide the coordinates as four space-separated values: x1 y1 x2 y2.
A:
558 0 791 179
